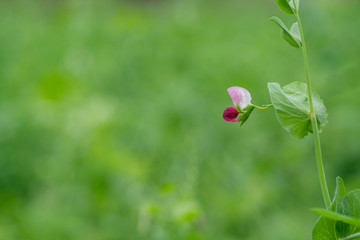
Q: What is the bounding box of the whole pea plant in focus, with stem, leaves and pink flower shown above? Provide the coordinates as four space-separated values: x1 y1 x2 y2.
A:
223 0 360 240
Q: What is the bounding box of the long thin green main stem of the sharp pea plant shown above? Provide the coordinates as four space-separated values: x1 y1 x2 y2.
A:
293 0 331 208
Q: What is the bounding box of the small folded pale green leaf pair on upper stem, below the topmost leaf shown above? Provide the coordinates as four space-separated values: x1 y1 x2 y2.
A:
270 17 302 48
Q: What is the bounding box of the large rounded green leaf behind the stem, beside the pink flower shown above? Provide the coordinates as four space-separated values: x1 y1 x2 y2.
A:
268 82 327 138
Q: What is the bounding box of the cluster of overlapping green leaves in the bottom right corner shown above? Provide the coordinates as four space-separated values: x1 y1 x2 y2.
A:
312 177 360 240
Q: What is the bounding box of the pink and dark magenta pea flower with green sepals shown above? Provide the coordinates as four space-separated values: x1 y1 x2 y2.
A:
223 86 254 125
